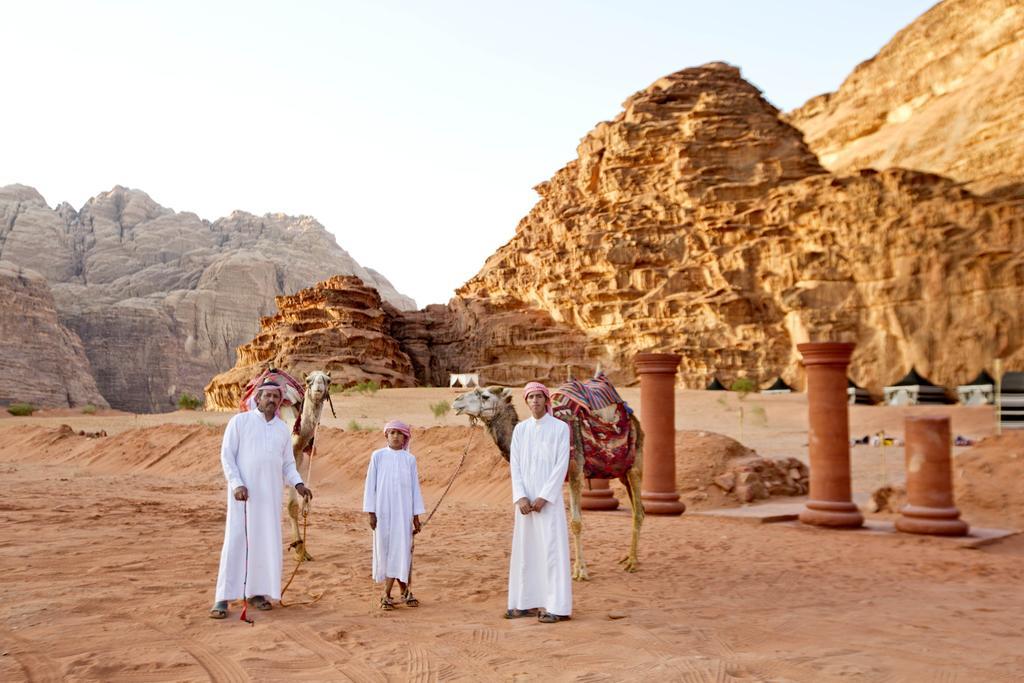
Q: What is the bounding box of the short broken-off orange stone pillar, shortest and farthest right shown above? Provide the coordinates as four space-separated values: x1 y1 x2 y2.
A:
896 416 970 536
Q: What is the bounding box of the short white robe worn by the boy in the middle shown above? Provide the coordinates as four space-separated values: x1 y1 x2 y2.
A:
362 447 426 584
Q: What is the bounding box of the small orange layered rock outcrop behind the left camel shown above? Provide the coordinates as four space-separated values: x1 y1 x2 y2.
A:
206 275 416 411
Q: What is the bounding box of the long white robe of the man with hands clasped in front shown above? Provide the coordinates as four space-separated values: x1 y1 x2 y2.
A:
509 415 572 616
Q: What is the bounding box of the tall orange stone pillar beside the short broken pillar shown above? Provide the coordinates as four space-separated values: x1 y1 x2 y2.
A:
797 342 864 528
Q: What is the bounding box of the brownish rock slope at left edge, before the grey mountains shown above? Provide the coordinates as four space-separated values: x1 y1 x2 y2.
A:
0 261 108 408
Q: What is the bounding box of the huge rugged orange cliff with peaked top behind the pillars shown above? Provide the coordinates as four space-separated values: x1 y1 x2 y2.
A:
449 65 1024 391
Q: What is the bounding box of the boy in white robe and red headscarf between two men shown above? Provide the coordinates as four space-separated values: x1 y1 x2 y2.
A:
362 420 426 609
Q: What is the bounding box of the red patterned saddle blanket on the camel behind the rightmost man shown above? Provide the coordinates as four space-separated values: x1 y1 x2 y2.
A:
551 373 637 479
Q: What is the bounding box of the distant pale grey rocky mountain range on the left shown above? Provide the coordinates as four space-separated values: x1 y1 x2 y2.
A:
0 185 415 412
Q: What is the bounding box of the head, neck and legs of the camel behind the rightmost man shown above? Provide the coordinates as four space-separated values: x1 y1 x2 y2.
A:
452 387 644 581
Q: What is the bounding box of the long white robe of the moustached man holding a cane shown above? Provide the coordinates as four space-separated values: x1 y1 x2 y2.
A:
216 411 302 601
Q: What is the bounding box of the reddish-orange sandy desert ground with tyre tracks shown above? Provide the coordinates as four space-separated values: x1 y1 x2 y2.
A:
0 389 1024 683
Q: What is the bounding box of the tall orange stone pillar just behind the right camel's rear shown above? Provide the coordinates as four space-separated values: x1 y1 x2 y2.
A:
635 353 684 515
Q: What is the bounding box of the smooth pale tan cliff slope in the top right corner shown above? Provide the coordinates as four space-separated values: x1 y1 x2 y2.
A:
788 0 1024 195
